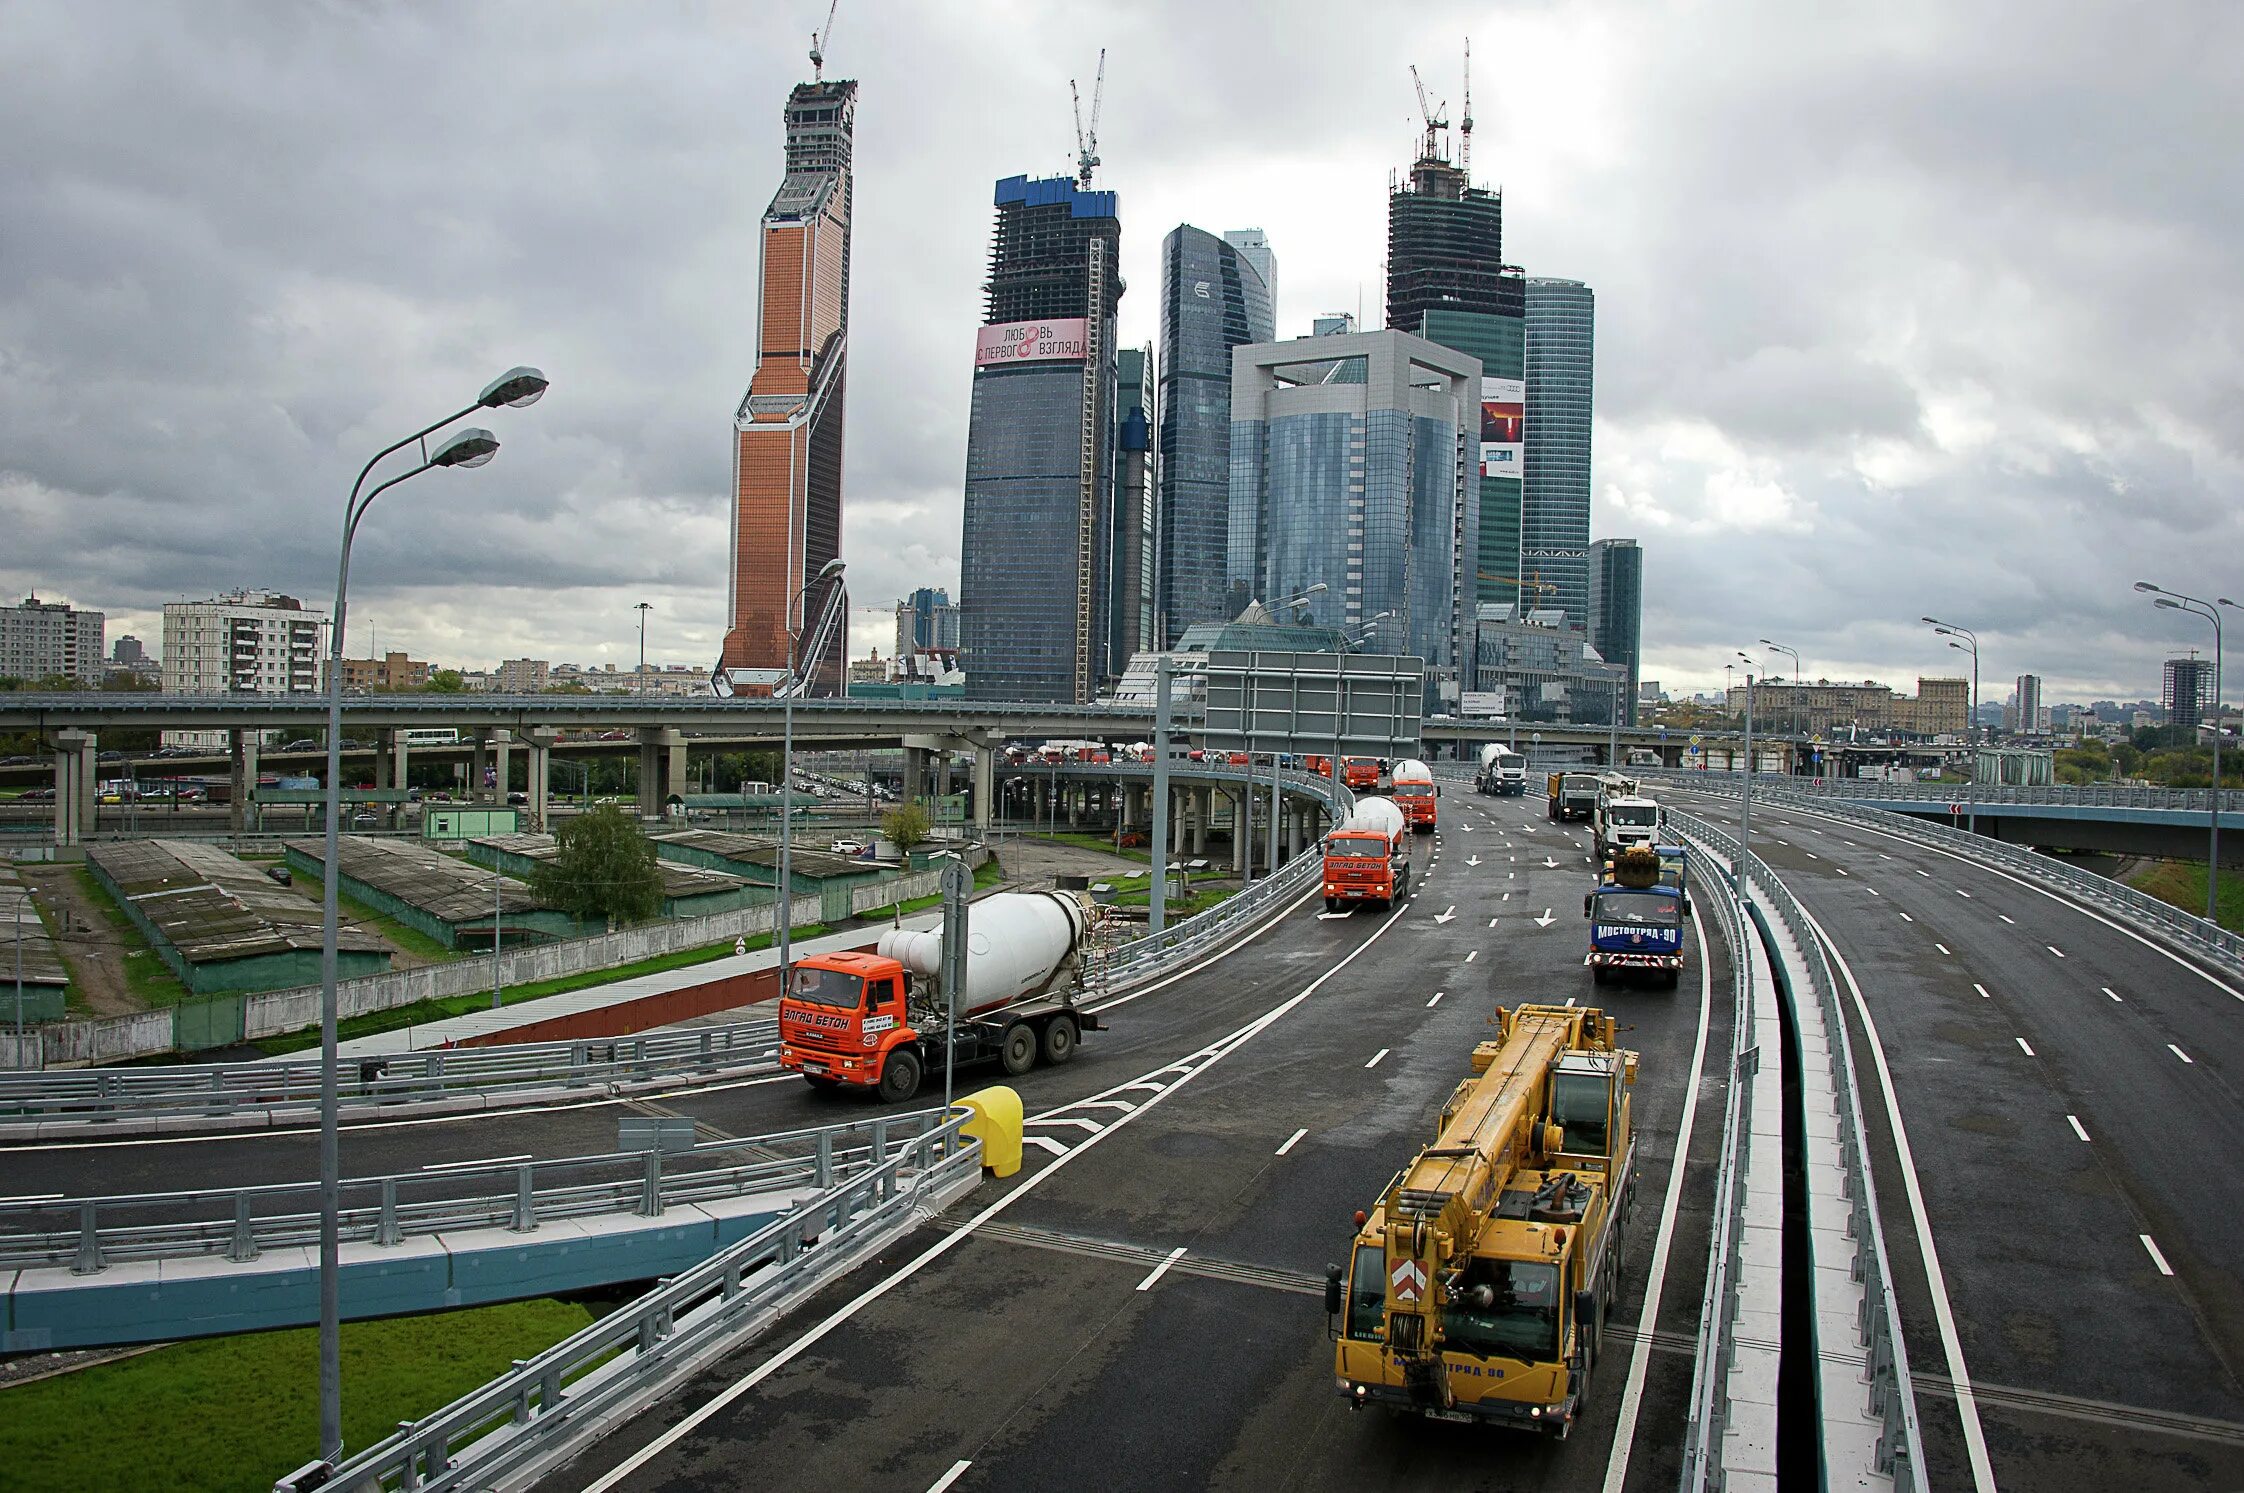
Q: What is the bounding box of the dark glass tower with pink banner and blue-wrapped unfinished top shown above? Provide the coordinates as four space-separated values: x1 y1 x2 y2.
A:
958 177 1129 700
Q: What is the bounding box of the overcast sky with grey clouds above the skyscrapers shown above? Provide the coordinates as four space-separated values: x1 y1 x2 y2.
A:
0 0 2244 698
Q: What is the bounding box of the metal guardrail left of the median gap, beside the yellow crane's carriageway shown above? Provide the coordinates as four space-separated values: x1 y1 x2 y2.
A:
1670 810 1762 1493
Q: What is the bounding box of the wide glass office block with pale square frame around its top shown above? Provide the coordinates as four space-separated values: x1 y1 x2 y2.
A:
1227 330 1481 689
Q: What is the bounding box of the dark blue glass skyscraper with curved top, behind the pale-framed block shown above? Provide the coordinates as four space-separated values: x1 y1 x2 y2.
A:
1153 225 1277 649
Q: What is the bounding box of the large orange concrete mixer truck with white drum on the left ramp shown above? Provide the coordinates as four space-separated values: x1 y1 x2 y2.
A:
779 891 1100 1102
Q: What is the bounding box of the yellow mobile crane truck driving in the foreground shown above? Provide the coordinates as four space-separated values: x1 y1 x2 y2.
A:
1324 1006 1636 1437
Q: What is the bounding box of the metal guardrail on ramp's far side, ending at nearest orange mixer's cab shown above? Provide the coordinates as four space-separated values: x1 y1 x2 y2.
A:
0 1017 779 1120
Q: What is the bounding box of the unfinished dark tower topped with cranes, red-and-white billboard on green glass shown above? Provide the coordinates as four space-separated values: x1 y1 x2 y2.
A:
1387 148 1535 606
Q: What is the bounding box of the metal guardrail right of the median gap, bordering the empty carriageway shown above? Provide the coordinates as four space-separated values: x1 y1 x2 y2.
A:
1670 810 1925 1493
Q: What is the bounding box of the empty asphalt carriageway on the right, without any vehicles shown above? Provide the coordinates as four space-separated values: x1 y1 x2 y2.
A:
1674 793 2244 1491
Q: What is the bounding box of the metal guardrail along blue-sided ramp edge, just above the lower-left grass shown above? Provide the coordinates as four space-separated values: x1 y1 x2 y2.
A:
0 1109 940 1275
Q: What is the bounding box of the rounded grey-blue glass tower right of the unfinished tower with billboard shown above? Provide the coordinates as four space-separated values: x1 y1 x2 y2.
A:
1519 278 1598 626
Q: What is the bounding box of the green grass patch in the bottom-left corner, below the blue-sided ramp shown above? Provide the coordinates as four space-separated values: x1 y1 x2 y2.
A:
0 1298 592 1493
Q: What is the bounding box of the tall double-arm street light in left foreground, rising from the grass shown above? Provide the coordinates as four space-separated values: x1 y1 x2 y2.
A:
319 368 545 1464
